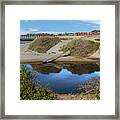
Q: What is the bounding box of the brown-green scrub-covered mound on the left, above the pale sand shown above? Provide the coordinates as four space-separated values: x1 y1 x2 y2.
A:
28 36 61 53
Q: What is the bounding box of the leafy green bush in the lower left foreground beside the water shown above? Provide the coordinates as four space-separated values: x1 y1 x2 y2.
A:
20 66 56 100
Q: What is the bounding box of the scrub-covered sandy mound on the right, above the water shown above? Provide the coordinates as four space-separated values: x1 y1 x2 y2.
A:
60 39 100 57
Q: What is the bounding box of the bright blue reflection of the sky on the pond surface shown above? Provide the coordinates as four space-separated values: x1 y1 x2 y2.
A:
22 64 100 93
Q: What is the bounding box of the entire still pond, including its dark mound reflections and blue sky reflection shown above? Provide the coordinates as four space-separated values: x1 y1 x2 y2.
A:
21 63 100 93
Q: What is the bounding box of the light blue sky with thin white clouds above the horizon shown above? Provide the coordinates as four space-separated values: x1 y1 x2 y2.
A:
20 20 100 34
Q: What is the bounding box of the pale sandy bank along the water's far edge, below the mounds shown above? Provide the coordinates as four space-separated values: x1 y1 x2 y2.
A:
20 44 100 63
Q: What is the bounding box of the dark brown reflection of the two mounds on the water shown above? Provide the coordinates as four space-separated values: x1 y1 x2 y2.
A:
32 63 100 74
